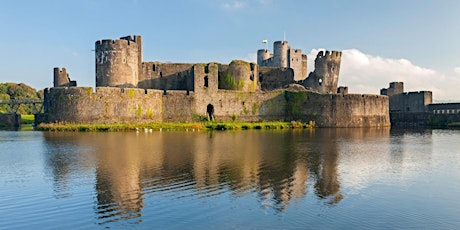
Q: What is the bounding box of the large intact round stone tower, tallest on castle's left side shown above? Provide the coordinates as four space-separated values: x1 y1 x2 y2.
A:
96 36 142 88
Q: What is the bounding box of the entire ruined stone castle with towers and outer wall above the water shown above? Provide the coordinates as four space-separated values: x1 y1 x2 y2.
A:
44 36 390 127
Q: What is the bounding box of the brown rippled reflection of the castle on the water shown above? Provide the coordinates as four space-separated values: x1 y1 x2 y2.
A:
44 129 390 224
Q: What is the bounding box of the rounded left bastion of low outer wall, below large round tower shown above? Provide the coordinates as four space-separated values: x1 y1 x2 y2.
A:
44 87 163 123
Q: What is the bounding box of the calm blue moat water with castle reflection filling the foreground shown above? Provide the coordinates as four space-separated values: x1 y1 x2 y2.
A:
0 129 460 229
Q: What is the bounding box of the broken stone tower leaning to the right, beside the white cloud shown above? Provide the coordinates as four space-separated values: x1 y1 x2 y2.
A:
303 51 342 93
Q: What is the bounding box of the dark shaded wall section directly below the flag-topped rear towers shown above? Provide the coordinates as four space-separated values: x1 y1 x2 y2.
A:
259 67 294 91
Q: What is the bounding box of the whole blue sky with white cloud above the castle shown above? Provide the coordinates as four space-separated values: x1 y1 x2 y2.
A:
0 0 460 101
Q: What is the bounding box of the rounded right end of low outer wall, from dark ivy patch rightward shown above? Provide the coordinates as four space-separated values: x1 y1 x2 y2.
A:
285 91 390 127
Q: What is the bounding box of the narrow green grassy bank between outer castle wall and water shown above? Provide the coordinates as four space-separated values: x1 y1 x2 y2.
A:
37 121 314 132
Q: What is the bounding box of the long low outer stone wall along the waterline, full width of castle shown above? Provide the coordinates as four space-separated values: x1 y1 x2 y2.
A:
45 87 389 127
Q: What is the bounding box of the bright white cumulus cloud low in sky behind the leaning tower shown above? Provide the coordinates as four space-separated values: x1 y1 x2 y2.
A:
308 49 460 100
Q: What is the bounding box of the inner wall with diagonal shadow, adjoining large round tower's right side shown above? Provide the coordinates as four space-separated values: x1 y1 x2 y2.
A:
138 62 194 91
